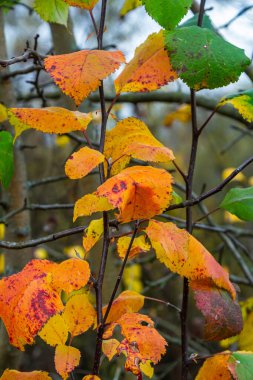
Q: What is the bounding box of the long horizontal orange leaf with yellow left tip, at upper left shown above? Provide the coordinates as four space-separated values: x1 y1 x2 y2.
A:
8 107 92 139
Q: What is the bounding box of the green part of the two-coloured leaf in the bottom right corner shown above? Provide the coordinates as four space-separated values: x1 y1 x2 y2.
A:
229 351 253 380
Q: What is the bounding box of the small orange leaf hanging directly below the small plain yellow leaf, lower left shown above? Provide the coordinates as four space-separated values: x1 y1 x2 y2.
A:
54 344 81 380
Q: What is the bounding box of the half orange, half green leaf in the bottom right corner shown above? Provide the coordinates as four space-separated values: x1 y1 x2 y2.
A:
196 351 253 380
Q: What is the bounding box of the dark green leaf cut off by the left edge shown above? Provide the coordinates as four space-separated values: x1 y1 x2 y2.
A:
0 131 14 188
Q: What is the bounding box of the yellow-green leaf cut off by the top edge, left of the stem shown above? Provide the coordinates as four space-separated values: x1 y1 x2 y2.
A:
34 0 68 26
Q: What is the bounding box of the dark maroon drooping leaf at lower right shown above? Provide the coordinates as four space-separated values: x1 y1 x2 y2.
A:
190 280 243 340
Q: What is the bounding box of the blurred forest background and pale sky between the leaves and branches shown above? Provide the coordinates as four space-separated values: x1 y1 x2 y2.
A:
0 0 253 380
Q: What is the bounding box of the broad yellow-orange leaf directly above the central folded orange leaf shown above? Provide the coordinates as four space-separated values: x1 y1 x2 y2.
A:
104 117 175 175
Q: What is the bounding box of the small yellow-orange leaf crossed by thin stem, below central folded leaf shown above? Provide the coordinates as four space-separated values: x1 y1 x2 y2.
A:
117 235 150 260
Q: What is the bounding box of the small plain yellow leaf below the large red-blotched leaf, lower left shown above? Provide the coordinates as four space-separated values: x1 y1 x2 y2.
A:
38 314 68 346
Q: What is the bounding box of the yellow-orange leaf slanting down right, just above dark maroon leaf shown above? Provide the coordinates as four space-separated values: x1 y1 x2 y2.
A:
146 220 236 299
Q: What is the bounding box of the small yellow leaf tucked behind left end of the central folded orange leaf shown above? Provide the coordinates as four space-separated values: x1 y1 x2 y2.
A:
73 193 114 221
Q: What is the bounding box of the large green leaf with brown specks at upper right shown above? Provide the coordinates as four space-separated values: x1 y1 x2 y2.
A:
165 26 250 90
